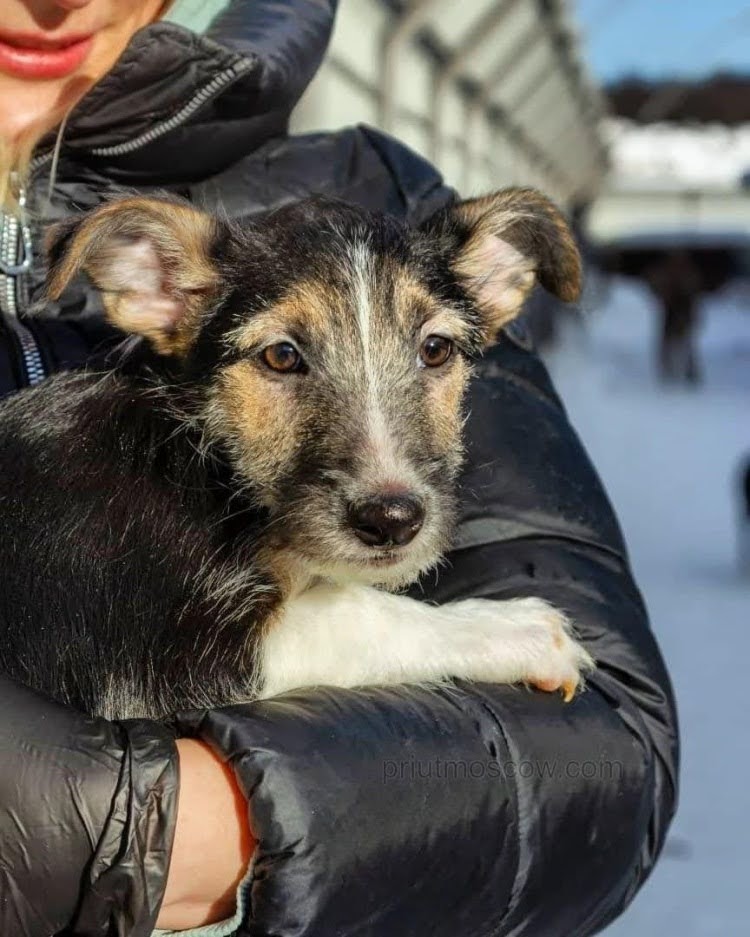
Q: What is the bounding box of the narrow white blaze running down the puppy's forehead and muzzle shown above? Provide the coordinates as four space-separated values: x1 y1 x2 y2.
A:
350 241 413 484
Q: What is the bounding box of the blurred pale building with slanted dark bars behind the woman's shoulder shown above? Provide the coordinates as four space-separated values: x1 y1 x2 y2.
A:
172 0 607 205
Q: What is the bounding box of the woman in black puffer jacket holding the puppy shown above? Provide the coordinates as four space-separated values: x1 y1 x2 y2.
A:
0 0 677 937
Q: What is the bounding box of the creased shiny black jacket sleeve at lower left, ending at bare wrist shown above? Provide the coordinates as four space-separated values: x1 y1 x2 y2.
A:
0 674 178 937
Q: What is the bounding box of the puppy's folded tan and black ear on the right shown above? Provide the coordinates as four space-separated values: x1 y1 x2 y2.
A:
428 188 581 342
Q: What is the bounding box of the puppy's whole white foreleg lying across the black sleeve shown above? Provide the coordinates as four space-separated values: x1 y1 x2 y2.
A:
260 583 593 697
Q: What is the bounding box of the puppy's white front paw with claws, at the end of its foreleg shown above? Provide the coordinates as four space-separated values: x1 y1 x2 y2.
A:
448 598 594 702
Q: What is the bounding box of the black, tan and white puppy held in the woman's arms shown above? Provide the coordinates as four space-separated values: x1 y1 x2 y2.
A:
0 189 592 717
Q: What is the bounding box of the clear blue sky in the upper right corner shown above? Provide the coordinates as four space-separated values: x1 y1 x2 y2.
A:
572 0 750 82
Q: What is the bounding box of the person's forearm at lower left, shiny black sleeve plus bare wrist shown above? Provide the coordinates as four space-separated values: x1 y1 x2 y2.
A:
0 675 262 937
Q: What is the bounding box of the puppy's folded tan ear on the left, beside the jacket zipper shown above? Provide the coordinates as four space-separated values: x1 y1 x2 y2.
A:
47 198 219 356
